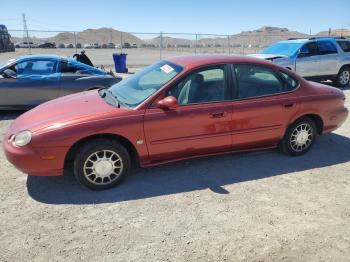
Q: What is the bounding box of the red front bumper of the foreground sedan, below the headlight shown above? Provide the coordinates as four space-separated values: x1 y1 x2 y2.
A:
3 137 68 176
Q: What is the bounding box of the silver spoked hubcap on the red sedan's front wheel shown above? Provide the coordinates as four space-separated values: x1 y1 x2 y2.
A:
84 150 123 185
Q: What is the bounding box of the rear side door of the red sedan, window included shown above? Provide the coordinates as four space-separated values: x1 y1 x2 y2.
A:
232 64 299 149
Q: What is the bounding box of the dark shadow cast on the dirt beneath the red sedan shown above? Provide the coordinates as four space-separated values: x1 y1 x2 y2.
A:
27 134 350 204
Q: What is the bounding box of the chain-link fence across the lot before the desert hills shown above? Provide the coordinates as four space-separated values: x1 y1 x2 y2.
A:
0 28 309 69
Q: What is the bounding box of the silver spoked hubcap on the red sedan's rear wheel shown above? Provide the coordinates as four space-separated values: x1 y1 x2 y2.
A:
290 123 313 152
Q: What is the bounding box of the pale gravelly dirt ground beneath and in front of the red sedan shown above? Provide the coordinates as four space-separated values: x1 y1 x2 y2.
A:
0 90 350 261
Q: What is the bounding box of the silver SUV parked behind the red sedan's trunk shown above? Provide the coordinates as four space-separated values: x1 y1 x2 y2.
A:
251 37 350 87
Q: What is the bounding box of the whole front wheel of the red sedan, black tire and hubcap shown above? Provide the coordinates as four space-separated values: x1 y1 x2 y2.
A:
74 138 131 190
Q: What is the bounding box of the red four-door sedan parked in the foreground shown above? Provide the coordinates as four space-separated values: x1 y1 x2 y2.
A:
3 56 348 189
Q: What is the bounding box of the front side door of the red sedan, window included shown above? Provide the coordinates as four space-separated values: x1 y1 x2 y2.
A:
144 65 232 161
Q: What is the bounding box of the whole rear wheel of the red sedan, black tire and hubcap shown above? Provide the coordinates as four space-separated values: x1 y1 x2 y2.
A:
280 117 316 156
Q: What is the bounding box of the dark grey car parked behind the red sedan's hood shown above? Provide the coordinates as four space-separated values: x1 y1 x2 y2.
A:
0 55 120 110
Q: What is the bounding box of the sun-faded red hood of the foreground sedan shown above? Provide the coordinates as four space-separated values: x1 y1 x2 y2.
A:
9 90 130 134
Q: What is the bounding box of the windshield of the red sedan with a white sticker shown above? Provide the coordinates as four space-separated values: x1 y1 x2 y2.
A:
111 61 182 107
